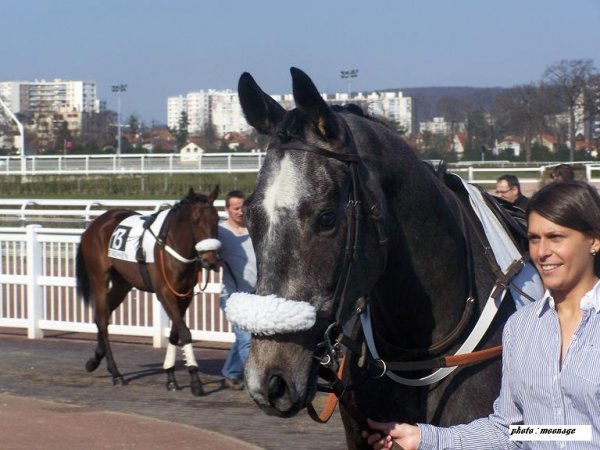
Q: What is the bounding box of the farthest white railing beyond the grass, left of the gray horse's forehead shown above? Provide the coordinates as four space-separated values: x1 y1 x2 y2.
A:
0 152 265 176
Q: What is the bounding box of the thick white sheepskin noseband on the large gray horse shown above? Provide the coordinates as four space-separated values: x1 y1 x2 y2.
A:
225 292 317 336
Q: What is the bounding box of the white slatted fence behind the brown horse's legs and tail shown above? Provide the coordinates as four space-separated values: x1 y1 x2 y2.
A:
0 225 234 347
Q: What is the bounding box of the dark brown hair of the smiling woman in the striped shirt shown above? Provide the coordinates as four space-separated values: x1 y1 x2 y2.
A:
527 180 600 237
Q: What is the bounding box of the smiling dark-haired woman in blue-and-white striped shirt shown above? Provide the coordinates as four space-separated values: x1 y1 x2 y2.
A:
363 181 600 450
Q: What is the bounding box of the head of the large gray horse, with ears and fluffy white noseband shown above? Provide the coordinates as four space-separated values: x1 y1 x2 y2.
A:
234 68 387 417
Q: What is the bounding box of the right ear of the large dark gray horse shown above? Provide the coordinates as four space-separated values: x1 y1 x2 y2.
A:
290 67 339 140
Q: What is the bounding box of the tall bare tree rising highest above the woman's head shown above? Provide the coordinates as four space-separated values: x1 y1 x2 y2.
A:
544 59 597 161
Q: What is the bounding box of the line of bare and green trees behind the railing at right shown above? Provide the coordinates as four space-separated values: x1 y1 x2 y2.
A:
412 59 600 162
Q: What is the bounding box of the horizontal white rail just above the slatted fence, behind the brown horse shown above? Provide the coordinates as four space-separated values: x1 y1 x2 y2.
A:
0 198 227 226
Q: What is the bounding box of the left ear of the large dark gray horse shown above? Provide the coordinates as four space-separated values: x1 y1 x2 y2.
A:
238 72 285 134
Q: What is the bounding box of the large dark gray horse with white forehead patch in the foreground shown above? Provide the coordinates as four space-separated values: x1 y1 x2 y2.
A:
229 68 514 448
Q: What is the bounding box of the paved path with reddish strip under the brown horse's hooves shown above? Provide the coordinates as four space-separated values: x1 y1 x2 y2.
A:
0 329 346 450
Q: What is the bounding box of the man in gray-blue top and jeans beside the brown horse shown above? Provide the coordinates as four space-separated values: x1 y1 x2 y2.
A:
219 191 256 390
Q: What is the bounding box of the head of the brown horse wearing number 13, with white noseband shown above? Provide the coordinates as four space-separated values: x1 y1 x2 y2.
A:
183 186 221 270
